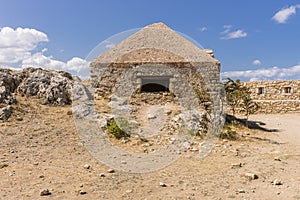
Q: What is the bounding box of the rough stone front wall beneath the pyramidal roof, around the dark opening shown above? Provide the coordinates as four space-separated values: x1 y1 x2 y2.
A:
91 63 222 109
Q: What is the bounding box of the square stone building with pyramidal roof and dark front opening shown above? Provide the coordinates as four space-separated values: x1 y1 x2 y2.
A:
90 23 221 111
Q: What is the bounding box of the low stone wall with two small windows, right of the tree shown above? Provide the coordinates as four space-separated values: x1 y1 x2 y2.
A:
243 80 300 113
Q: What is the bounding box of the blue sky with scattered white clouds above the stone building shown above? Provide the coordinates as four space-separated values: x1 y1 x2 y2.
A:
0 0 300 80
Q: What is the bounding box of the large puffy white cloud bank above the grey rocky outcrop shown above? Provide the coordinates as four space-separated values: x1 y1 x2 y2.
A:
0 27 89 78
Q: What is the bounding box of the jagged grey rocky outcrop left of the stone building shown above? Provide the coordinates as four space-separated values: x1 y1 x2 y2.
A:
0 68 80 120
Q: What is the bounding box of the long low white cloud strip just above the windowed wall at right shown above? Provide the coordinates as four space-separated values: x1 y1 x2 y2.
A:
222 65 300 81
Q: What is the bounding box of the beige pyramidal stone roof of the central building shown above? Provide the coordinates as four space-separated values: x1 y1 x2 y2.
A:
91 23 219 66
